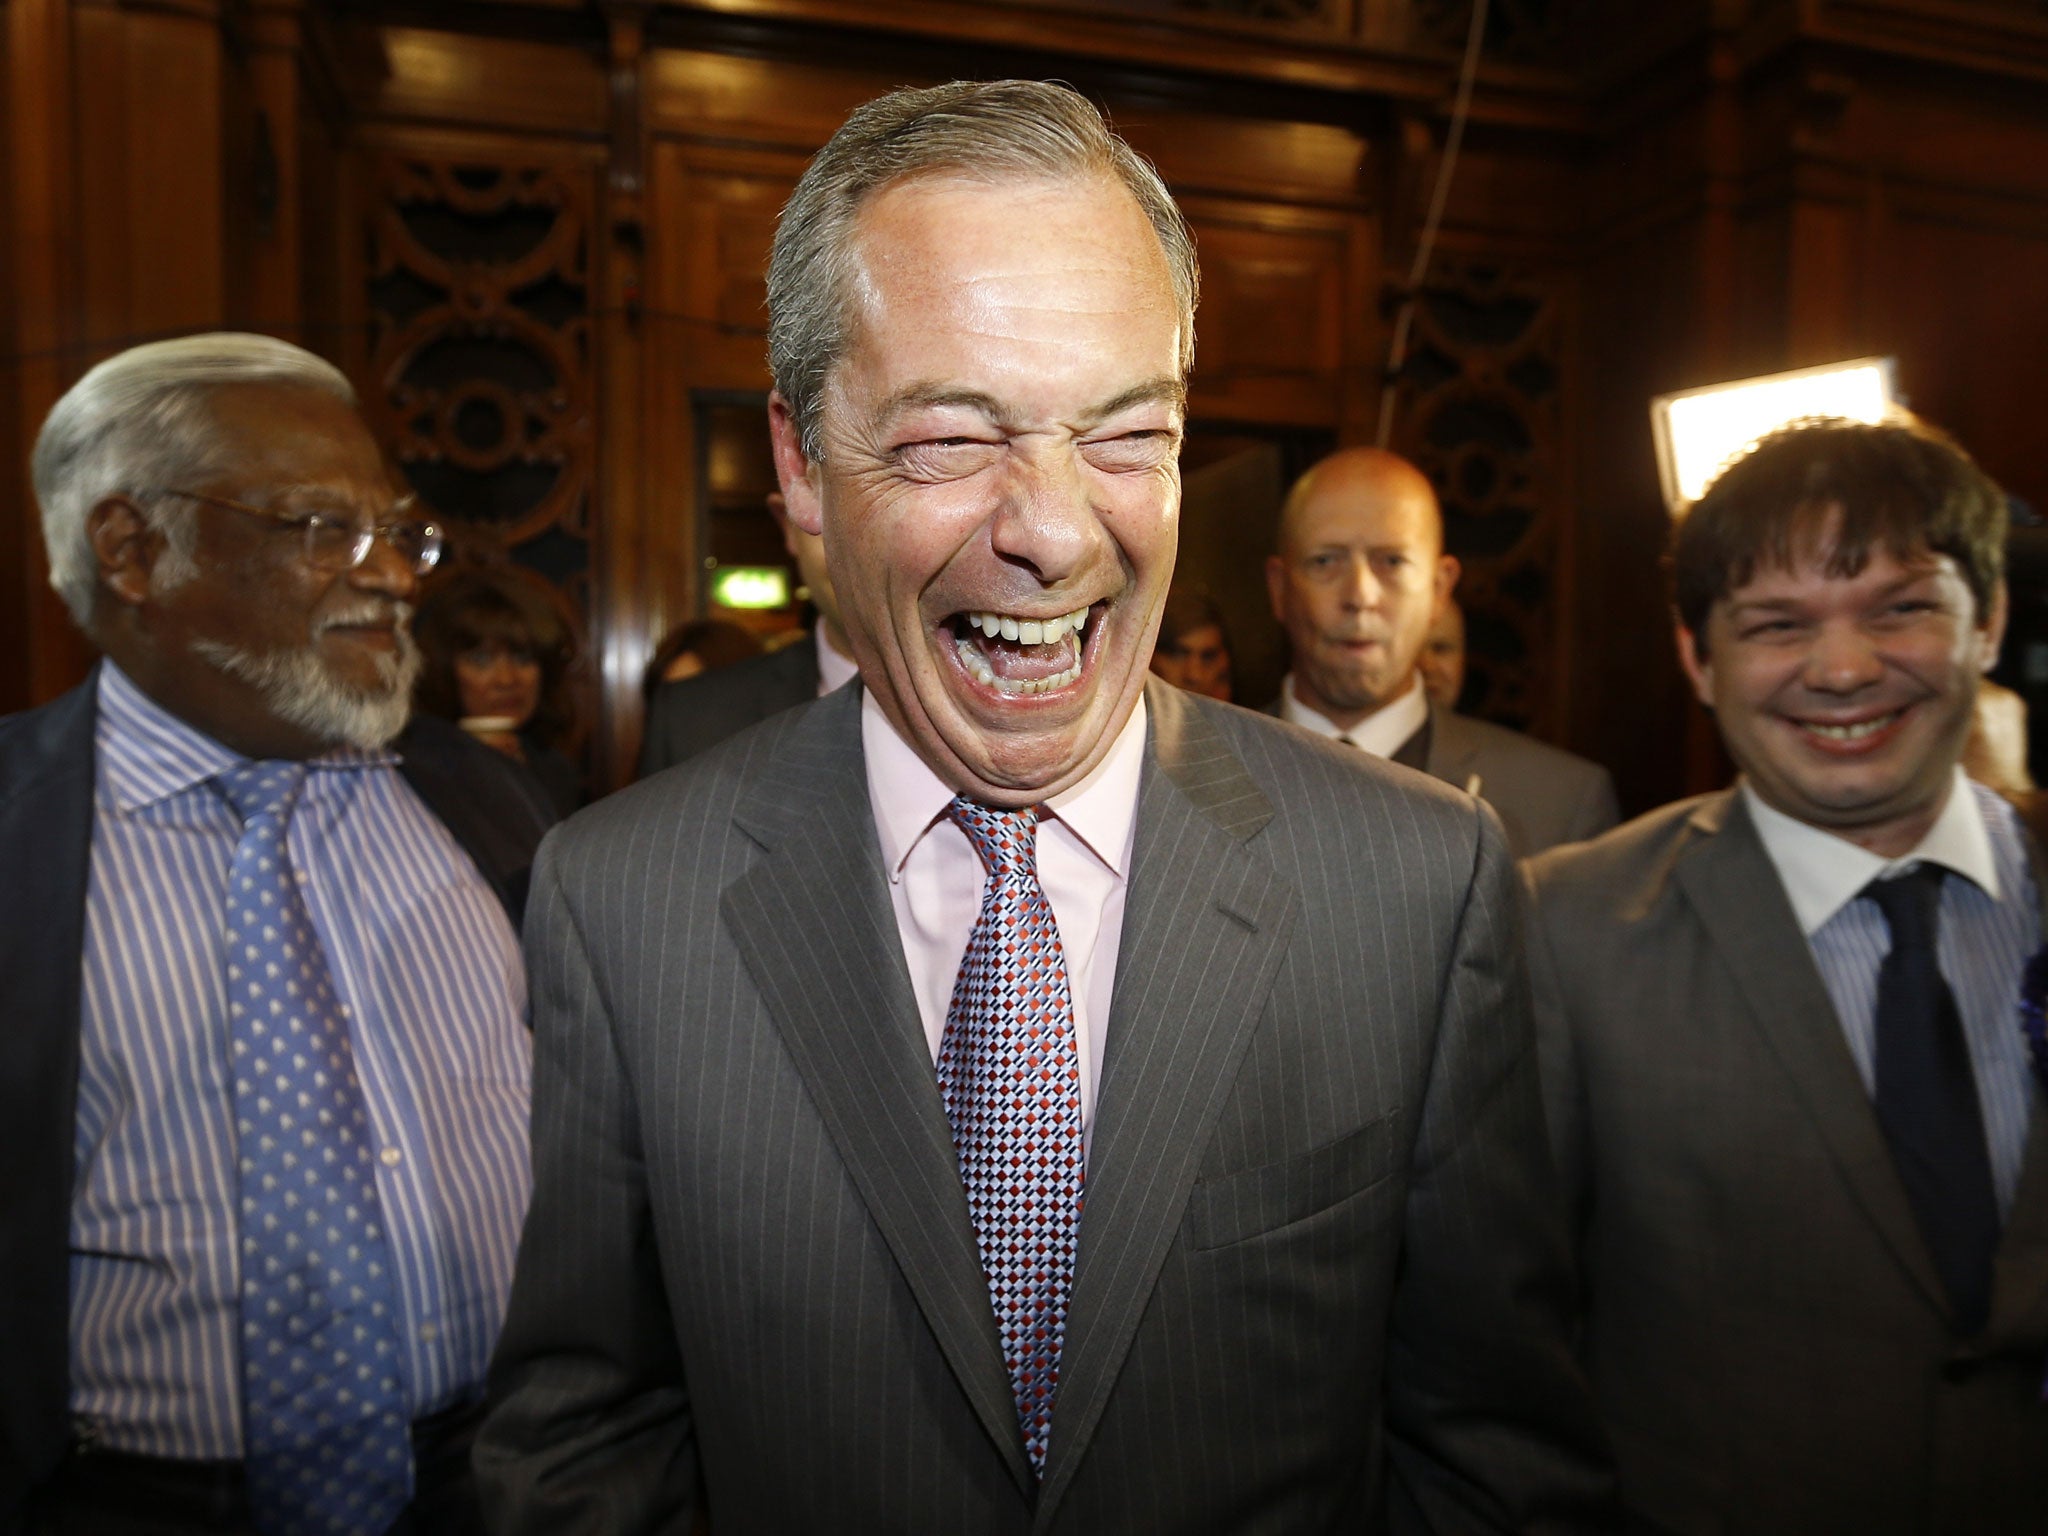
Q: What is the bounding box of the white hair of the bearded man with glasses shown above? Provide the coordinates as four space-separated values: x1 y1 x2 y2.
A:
33 332 356 629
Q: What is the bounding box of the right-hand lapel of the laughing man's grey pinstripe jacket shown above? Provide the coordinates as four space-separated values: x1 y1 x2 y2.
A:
1038 684 1294 1530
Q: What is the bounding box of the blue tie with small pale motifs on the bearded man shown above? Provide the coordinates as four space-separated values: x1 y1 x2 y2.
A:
219 762 412 1536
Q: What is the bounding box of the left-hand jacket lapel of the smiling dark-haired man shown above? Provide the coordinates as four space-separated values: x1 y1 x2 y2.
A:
1677 791 1948 1311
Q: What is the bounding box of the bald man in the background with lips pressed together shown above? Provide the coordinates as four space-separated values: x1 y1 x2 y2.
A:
1266 449 1618 858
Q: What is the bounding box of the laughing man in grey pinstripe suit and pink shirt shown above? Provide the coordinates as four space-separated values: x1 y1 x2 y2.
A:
479 82 1608 1536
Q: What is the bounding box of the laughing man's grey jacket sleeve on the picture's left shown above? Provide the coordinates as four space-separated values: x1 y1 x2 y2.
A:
475 838 696 1536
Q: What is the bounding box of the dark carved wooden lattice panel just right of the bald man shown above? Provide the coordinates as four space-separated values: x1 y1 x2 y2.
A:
1395 256 1565 727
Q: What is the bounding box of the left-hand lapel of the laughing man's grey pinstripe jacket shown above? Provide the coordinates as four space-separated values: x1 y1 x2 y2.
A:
721 688 1032 1495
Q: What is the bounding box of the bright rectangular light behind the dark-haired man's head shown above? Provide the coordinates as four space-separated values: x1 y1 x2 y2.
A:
1651 356 1896 516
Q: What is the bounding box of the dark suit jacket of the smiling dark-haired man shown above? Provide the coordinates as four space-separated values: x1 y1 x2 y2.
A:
1528 791 2048 1536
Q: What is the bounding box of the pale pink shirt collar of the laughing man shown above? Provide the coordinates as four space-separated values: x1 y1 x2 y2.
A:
860 692 1145 883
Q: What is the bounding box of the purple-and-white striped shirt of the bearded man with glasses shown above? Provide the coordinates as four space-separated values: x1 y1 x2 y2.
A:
72 662 532 1460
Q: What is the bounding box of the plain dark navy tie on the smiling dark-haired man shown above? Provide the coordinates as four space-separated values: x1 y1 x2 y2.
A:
1864 864 1999 1333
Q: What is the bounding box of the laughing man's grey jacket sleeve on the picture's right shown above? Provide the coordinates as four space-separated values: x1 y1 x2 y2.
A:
1386 811 1618 1534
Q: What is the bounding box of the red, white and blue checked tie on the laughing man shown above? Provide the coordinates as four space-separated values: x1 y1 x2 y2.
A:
938 797 1083 1475
